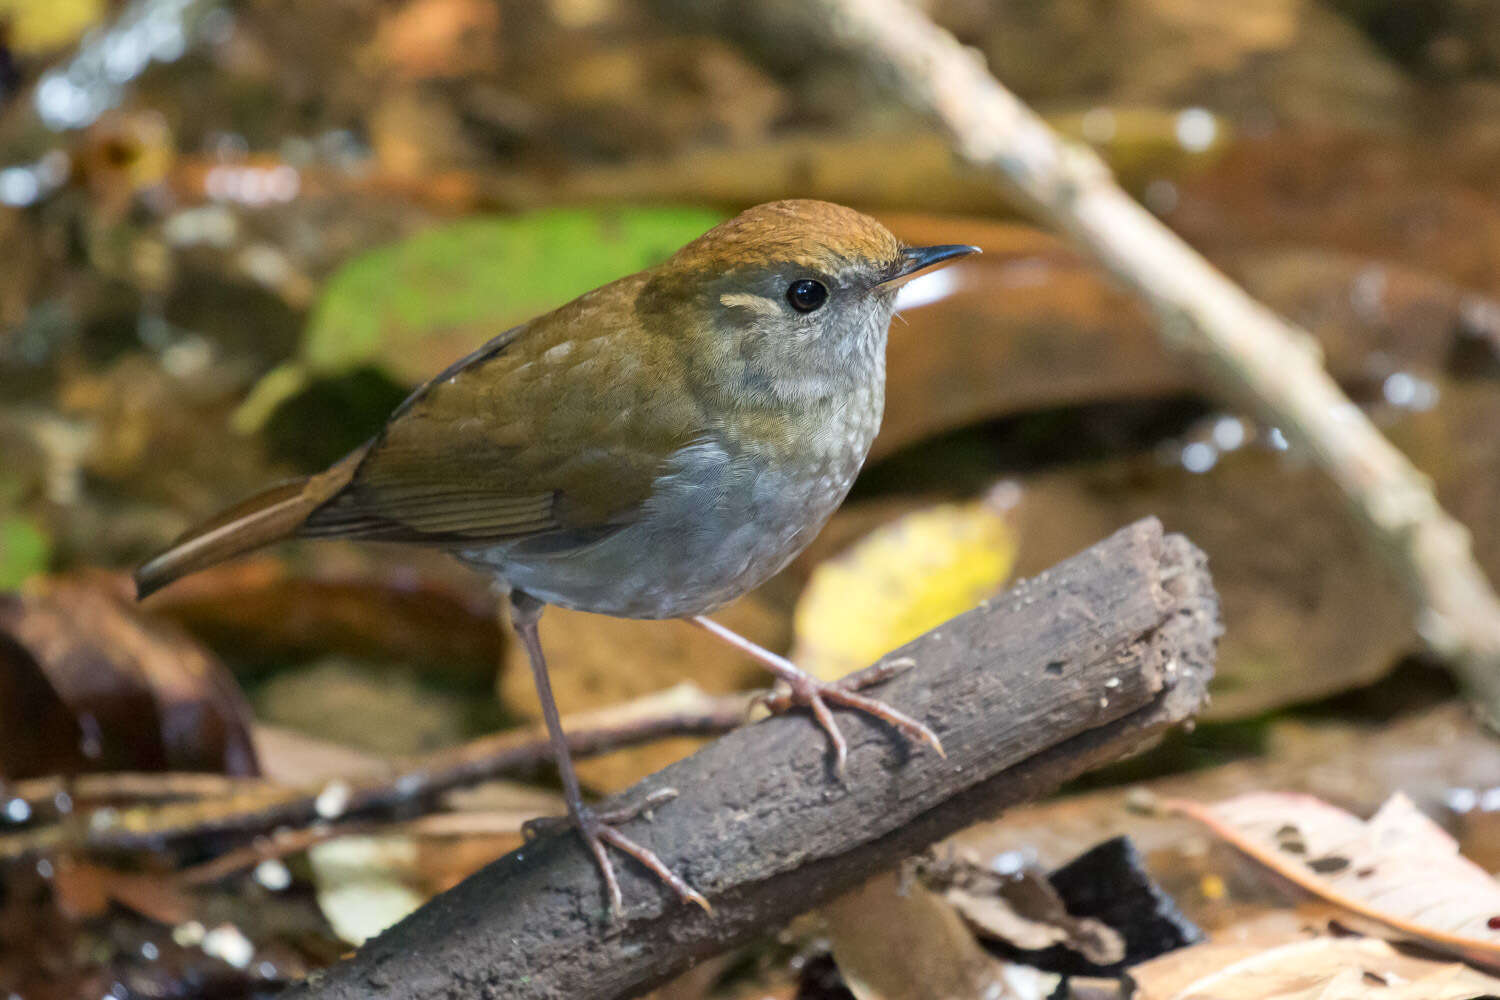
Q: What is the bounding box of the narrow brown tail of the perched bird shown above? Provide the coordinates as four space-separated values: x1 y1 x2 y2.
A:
135 448 365 598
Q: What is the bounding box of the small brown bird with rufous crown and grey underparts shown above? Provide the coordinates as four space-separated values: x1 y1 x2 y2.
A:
135 201 978 912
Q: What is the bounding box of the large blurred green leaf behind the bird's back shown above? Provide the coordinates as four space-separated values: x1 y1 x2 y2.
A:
236 207 725 430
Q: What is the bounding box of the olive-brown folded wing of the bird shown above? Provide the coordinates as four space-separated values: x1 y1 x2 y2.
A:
300 279 702 549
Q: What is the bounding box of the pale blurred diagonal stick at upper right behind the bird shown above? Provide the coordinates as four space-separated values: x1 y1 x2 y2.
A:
747 0 1500 724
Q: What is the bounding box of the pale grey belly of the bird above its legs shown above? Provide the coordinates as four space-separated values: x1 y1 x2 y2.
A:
459 441 869 618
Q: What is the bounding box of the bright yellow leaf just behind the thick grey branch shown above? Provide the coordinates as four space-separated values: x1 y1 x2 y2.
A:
792 493 1016 681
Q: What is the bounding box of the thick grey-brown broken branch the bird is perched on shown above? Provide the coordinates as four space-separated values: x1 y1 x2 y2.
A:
288 519 1220 1000
